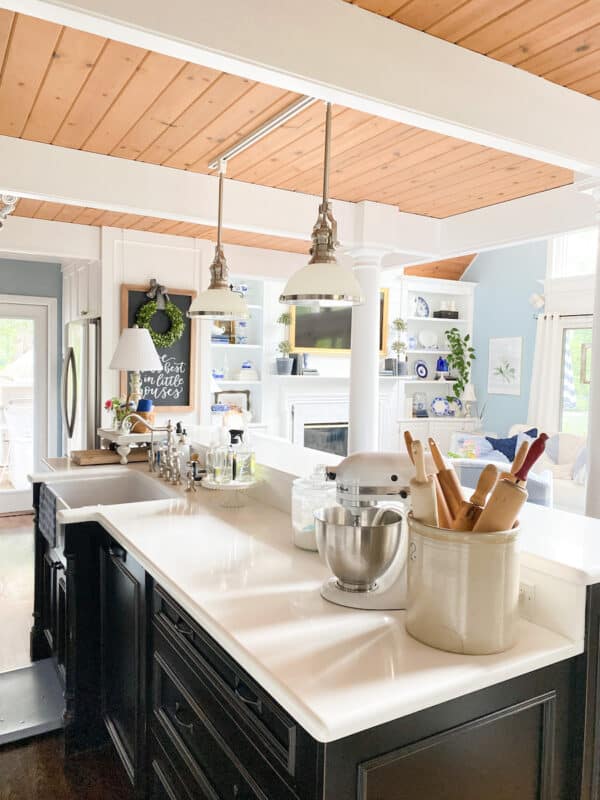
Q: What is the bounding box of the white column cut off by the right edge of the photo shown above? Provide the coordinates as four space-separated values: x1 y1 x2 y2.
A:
585 195 600 519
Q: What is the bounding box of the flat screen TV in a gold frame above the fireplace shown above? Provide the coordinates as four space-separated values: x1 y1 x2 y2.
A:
290 289 388 355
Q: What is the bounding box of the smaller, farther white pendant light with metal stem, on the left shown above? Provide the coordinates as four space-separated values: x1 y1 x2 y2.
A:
187 161 250 320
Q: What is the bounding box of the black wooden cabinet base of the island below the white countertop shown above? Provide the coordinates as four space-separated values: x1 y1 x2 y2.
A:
32 490 600 800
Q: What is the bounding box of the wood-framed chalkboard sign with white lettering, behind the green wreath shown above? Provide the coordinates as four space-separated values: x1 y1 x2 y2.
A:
121 284 196 411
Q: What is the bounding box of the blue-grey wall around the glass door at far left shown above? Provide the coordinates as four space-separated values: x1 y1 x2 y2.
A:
0 259 62 453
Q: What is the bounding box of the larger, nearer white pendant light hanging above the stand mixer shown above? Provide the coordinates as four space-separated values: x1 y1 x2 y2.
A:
279 103 363 307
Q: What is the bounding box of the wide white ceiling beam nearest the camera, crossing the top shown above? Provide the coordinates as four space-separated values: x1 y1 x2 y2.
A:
7 0 600 175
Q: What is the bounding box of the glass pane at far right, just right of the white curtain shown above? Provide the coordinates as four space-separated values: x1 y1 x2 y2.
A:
560 328 592 436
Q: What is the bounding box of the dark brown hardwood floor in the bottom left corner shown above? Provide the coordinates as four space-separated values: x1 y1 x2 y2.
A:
0 734 133 800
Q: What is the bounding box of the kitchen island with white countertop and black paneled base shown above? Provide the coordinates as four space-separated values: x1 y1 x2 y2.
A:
32 446 600 800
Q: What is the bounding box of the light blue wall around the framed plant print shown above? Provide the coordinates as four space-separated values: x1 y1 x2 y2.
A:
463 242 547 435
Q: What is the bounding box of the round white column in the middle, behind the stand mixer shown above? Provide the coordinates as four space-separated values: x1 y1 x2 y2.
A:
348 249 383 454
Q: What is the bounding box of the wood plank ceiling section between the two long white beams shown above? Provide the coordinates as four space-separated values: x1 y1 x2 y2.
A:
0 8 572 225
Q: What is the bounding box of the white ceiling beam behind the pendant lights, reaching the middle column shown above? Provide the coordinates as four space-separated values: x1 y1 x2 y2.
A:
0 136 437 255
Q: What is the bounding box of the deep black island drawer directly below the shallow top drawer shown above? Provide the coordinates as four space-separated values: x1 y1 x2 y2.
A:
153 654 267 800
